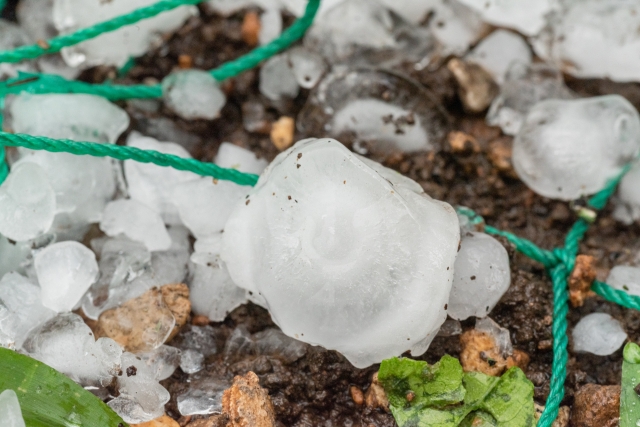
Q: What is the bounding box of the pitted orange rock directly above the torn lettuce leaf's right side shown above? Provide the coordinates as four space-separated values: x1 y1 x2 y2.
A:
460 329 529 376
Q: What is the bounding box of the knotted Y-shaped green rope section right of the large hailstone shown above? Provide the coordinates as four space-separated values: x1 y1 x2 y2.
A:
458 165 640 427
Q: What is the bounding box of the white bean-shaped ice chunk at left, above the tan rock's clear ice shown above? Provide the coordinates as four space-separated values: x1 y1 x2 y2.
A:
100 200 171 252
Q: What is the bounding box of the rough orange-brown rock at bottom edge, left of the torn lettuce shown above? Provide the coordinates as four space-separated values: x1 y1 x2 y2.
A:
222 372 276 427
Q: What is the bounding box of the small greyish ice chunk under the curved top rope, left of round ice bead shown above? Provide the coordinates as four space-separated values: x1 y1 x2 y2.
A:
260 53 300 101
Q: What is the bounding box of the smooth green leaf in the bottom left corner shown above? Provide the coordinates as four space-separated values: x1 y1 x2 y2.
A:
0 348 127 427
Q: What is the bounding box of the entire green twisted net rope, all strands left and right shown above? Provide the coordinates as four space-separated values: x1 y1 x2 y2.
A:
0 0 640 427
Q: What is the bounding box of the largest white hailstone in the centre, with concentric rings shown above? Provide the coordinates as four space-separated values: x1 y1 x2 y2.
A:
222 139 460 368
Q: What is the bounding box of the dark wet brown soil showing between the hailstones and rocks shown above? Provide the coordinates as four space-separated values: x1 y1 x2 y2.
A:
10 1 640 427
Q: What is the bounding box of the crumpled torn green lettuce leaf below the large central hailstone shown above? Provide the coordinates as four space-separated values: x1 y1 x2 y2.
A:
378 356 536 427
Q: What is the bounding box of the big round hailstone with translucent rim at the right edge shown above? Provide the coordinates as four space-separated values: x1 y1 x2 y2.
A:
513 95 640 200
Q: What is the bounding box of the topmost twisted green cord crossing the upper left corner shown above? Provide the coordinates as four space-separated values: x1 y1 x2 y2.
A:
0 0 204 62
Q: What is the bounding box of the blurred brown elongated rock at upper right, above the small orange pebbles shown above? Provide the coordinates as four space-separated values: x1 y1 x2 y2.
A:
447 58 499 113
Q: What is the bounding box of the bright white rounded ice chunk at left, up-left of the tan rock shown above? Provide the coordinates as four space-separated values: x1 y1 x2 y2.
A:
34 242 99 312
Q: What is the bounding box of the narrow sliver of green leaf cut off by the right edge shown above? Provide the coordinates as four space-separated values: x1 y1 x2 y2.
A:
620 342 640 427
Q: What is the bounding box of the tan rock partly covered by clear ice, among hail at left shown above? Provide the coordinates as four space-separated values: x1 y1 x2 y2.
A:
94 283 191 352
